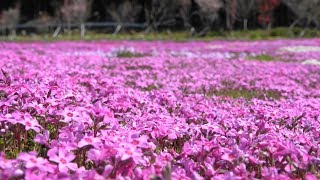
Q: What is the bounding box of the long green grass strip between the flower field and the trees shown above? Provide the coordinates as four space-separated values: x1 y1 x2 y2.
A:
0 27 320 42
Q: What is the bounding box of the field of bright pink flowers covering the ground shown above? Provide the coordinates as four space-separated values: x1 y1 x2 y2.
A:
0 39 320 180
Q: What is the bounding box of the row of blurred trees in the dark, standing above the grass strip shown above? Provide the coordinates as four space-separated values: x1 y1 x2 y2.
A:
0 0 320 35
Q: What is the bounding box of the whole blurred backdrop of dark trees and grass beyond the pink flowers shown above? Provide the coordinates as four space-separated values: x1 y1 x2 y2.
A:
0 0 320 39
